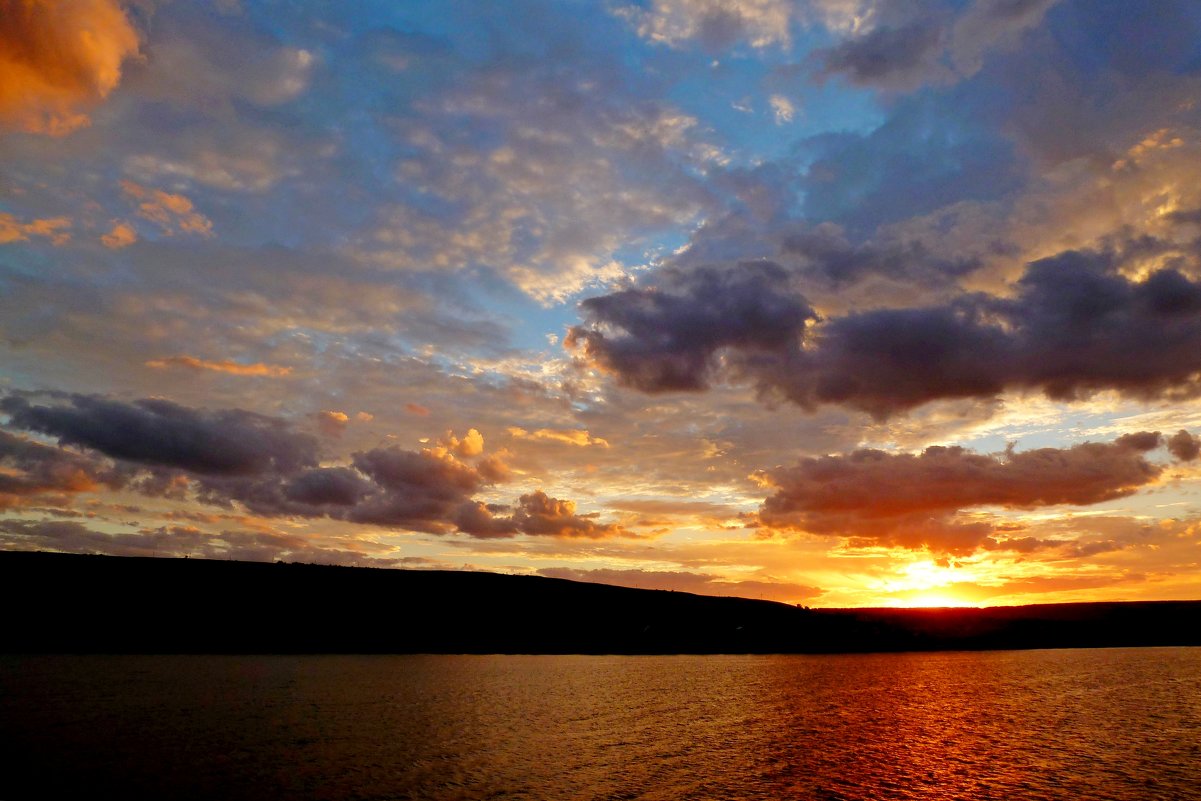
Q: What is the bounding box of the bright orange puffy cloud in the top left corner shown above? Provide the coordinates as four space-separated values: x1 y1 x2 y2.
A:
0 0 138 136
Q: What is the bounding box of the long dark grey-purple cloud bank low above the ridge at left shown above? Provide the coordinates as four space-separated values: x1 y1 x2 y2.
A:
0 393 625 538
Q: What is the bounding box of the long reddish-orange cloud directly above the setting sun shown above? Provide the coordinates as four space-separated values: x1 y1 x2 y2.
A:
755 431 1163 554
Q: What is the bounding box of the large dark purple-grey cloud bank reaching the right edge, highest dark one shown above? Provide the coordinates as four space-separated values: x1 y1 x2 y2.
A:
567 244 1201 418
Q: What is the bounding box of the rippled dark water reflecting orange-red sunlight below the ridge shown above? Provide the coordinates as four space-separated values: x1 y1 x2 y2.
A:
0 648 1201 801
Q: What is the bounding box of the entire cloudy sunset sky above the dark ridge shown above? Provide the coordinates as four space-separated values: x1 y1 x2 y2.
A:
0 0 1201 606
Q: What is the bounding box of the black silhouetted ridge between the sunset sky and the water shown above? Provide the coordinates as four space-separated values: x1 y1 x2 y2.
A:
0 551 1201 653
